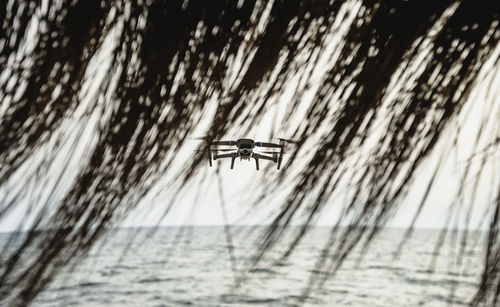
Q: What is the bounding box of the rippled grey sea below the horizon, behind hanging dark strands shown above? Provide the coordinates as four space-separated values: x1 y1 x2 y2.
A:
18 226 485 307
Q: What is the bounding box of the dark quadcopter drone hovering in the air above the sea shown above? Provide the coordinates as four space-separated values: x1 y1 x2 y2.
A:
194 137 297 170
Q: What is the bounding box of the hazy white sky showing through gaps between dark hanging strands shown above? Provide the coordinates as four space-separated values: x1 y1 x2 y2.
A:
0 2 500 231
